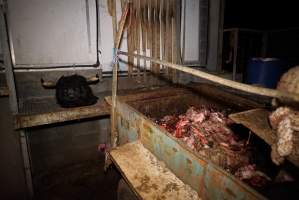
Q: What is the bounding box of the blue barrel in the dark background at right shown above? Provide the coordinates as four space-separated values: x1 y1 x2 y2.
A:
245 58 286 88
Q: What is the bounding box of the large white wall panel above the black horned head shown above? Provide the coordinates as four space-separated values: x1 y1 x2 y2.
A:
8 0 97 67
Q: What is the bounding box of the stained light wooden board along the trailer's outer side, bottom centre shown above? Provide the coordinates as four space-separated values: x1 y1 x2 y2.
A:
110 141 200 200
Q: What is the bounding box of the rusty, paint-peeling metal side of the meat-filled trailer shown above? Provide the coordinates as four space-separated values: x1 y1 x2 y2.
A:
117 90 264 199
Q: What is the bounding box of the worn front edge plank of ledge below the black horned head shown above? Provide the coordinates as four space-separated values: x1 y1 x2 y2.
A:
15 100 111 129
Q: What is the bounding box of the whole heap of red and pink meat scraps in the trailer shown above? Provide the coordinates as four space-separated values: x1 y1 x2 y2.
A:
156 107 268 187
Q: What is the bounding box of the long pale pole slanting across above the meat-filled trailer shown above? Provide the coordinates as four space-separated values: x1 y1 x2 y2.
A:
118 51 299 103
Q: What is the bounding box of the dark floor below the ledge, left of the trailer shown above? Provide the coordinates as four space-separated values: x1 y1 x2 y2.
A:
35 157 120 200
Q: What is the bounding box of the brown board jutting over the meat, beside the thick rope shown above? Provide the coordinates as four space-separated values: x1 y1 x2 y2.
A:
229 109 276 145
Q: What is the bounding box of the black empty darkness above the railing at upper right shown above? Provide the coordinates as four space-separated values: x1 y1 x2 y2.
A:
224 0 299 30
